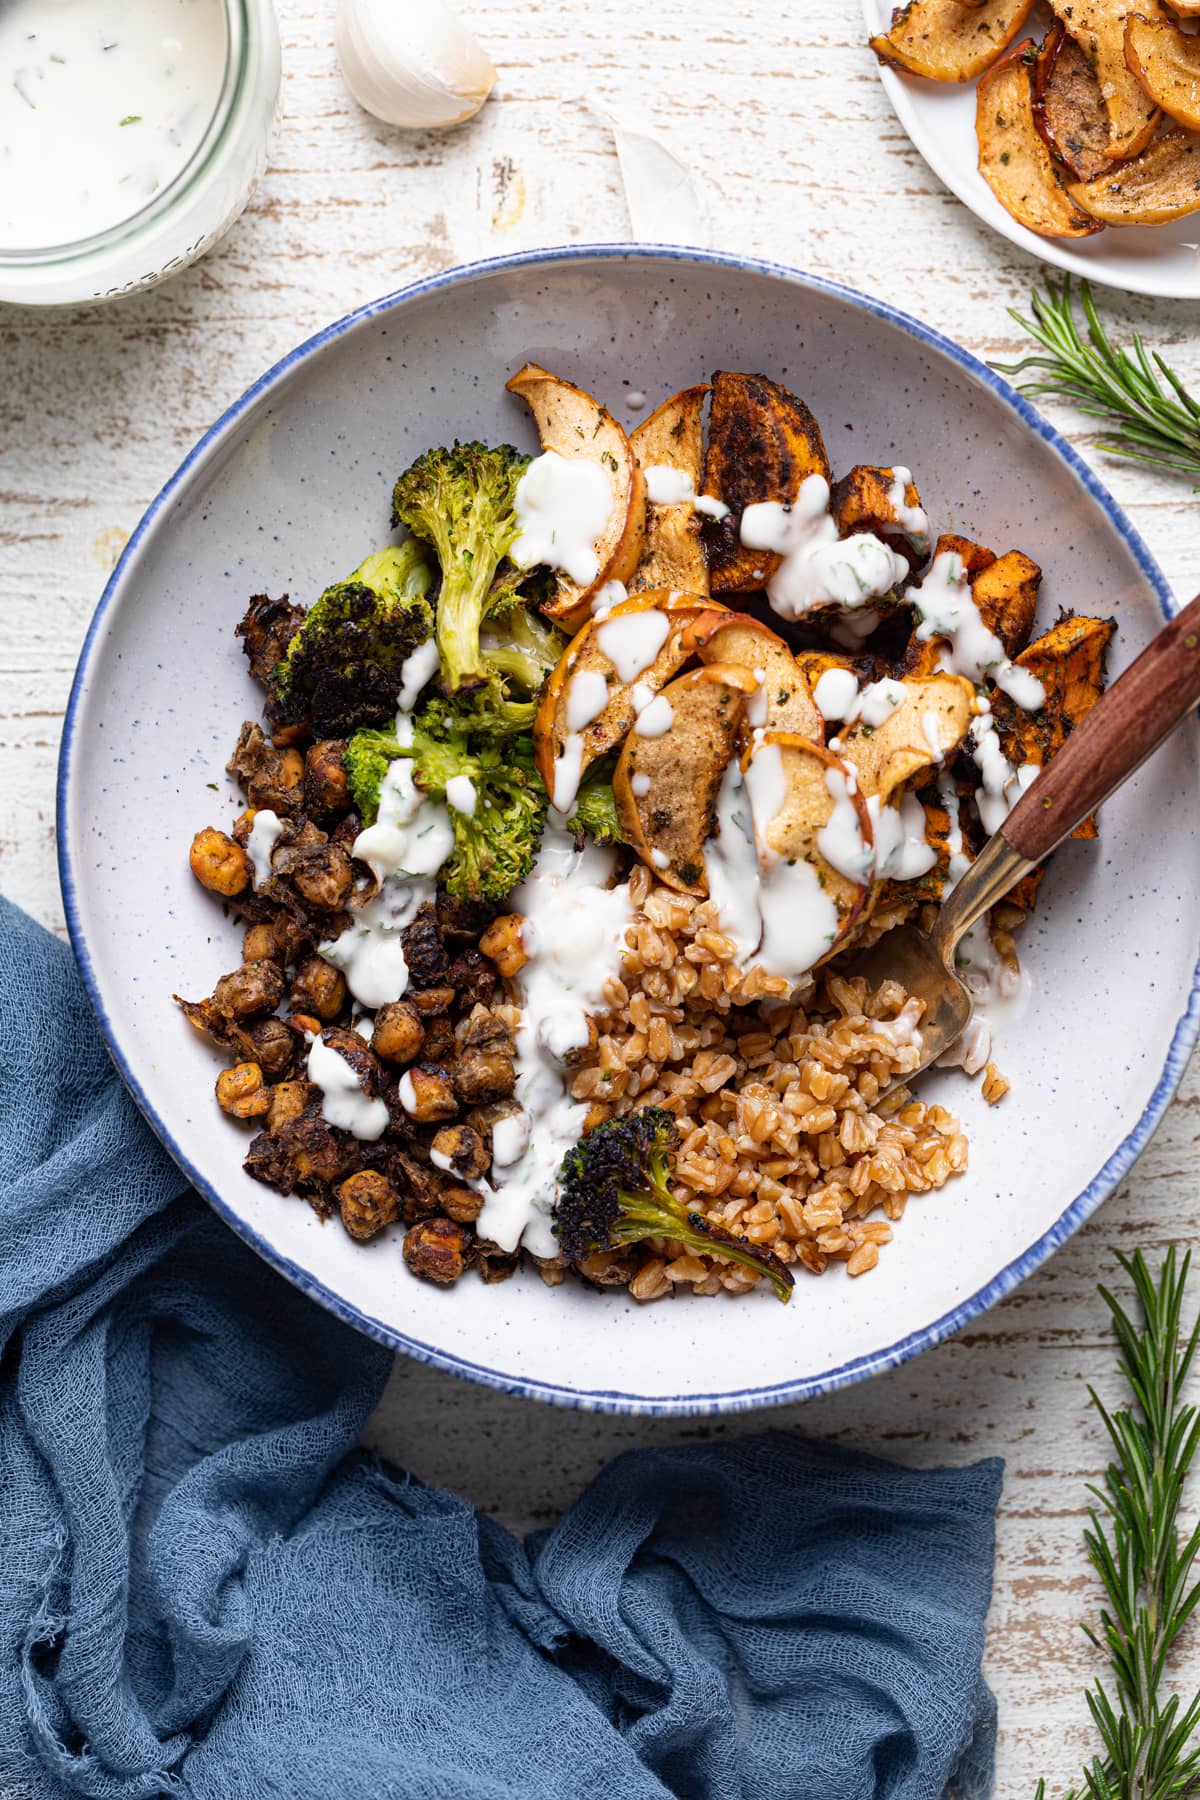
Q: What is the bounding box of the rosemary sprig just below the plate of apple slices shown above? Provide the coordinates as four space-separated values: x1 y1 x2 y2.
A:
993 275 1200 475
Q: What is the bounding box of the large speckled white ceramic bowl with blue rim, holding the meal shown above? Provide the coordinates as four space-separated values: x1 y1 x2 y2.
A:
59 247 1200 1413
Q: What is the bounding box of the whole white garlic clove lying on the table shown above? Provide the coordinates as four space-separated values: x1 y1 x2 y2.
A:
335 0 497 131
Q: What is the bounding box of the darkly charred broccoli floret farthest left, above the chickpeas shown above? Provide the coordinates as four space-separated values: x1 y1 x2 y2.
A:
270 538 434 738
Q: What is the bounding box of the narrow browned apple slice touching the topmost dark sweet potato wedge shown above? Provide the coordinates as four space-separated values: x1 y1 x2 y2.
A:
628 382 709 594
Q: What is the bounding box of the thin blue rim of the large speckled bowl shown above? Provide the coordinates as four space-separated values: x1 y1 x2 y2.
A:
56 243 1200 1417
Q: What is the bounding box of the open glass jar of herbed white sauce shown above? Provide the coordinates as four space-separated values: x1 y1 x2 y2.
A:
0 0 281 306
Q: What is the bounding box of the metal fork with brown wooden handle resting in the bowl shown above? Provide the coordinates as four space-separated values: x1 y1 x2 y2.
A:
847 596 1200 1085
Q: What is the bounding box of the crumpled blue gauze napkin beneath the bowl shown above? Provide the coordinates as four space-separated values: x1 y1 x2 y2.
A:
0 902 1000 1800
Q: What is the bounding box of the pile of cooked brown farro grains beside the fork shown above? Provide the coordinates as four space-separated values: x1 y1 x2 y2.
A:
572 868 971 1300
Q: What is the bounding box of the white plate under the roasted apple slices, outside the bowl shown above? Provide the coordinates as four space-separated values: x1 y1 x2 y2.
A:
862 0 1200 301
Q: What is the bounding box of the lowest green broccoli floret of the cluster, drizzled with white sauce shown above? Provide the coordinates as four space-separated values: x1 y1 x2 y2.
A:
345 702 547 900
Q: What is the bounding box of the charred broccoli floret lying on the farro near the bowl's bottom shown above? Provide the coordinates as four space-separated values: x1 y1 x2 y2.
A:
554 1107 793 1301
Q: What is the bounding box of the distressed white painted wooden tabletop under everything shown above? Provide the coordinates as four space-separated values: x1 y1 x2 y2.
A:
0 0 1200 1796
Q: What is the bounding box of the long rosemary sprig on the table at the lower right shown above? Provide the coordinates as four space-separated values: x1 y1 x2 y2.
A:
1036 1246 1200 1800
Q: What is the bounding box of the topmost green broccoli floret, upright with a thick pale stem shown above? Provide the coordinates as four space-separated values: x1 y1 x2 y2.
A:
392 443 529 693
